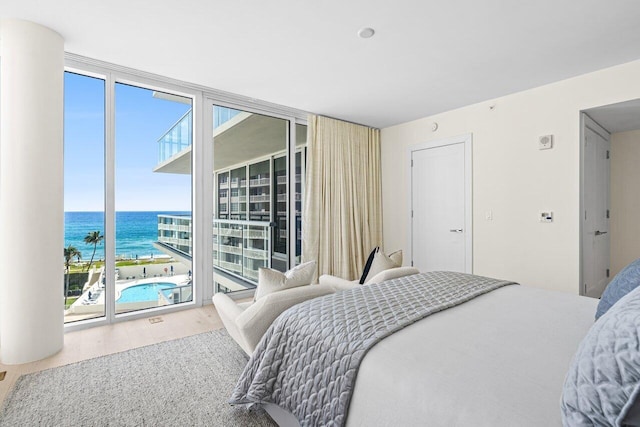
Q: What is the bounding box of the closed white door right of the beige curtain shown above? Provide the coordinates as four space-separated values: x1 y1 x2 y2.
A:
411 136 471 273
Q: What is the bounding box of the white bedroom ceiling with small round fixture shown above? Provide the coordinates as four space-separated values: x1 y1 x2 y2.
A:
0 0 640 127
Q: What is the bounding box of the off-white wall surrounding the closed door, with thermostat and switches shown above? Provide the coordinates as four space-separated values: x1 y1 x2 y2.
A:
382 61 640 293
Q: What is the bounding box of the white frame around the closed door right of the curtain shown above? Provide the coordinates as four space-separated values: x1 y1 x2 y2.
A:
406 133 473 274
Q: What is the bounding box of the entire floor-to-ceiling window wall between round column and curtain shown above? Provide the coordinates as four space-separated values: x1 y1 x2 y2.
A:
62 60 306 328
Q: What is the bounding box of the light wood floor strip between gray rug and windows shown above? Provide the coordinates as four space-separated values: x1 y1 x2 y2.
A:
0 305 223 403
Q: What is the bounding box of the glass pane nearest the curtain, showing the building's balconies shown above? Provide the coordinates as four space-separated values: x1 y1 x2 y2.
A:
211 105 289 292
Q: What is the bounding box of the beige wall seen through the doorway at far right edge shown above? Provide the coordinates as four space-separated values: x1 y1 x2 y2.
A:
610 130 640 277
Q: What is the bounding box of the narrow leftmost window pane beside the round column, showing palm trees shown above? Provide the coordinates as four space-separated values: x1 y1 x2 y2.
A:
64 72 105 322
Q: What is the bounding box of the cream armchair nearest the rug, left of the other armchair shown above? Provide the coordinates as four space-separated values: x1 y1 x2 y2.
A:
213 285 335 355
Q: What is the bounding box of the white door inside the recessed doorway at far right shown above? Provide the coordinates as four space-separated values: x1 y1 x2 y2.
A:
581 120 611 298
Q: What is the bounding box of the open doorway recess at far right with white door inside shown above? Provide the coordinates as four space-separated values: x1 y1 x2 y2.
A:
580 100 640 298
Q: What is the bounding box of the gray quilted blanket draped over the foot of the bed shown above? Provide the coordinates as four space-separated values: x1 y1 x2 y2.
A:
230 272 513 426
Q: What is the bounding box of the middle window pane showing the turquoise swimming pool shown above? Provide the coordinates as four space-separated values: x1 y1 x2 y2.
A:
114 83 193 313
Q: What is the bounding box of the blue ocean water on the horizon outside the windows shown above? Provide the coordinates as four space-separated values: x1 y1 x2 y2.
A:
65 211 190 261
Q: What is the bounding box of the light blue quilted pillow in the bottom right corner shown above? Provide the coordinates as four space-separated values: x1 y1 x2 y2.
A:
561 288 640 427
